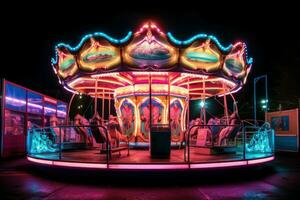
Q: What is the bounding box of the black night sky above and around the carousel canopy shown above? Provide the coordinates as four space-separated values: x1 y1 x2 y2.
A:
1 4 300 119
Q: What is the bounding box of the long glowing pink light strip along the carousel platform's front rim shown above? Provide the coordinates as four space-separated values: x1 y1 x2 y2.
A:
27 156 275 170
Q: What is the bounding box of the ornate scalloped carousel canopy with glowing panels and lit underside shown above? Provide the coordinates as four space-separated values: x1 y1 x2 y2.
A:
52 22 252 99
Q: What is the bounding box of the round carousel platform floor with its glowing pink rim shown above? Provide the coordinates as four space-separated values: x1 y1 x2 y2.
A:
27 148 274 170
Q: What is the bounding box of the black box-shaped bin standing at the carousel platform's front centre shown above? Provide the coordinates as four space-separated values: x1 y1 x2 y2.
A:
150 124 171 158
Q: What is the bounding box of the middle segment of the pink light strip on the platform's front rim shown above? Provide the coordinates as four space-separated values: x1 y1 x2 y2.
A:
109 164 189 169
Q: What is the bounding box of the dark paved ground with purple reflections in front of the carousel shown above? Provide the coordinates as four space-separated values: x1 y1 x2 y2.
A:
0 154 300 200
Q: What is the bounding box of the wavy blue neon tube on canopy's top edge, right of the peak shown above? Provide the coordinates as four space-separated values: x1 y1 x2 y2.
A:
167 32 232 51
